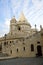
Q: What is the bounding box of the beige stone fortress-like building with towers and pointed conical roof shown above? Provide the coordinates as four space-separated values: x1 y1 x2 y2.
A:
0 13 43 57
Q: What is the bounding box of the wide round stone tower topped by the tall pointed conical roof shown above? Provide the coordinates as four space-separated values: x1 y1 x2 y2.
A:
17 12 31 31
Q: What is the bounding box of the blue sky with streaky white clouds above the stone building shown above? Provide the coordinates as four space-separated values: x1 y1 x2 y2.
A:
0 0 43 36
